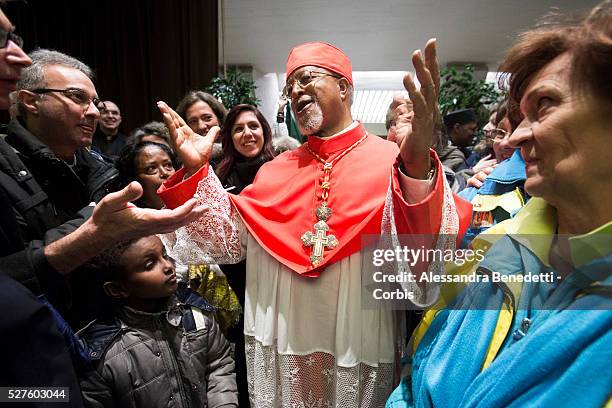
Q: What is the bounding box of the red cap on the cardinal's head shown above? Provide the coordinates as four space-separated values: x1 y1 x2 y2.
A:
285 42 353 85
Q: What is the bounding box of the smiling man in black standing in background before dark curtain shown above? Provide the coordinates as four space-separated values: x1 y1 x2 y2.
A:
91 101 127 161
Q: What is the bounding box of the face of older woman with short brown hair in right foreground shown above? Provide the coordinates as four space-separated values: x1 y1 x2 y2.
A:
509 54 612 205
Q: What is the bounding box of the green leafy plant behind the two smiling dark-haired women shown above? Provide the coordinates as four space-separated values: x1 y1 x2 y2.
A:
206 67 259 109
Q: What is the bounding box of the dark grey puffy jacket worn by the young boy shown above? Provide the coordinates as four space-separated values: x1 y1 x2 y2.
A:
79 287 238 408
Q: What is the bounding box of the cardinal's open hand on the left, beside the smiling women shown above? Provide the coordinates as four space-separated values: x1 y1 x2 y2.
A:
157 101 220 175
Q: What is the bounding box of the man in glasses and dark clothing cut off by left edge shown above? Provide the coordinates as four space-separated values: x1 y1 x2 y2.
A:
0 6 88 407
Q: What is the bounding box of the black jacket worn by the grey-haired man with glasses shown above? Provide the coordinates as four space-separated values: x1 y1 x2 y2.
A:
0 120 118 309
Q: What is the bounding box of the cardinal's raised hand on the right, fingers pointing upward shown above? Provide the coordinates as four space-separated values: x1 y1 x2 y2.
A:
397 39 440 179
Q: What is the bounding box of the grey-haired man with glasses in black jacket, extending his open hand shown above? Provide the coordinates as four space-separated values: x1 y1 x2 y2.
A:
0 41 208 323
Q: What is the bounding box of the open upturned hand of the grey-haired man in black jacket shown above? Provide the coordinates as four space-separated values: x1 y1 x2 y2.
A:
88 182 204 242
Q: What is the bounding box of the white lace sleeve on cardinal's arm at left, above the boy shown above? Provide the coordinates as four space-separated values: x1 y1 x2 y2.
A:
160 170 247 265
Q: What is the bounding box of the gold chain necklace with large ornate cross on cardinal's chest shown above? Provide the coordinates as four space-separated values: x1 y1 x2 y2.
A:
300 133 368 267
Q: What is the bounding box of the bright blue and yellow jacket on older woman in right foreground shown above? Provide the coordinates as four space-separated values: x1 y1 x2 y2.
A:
387 199 612 408
